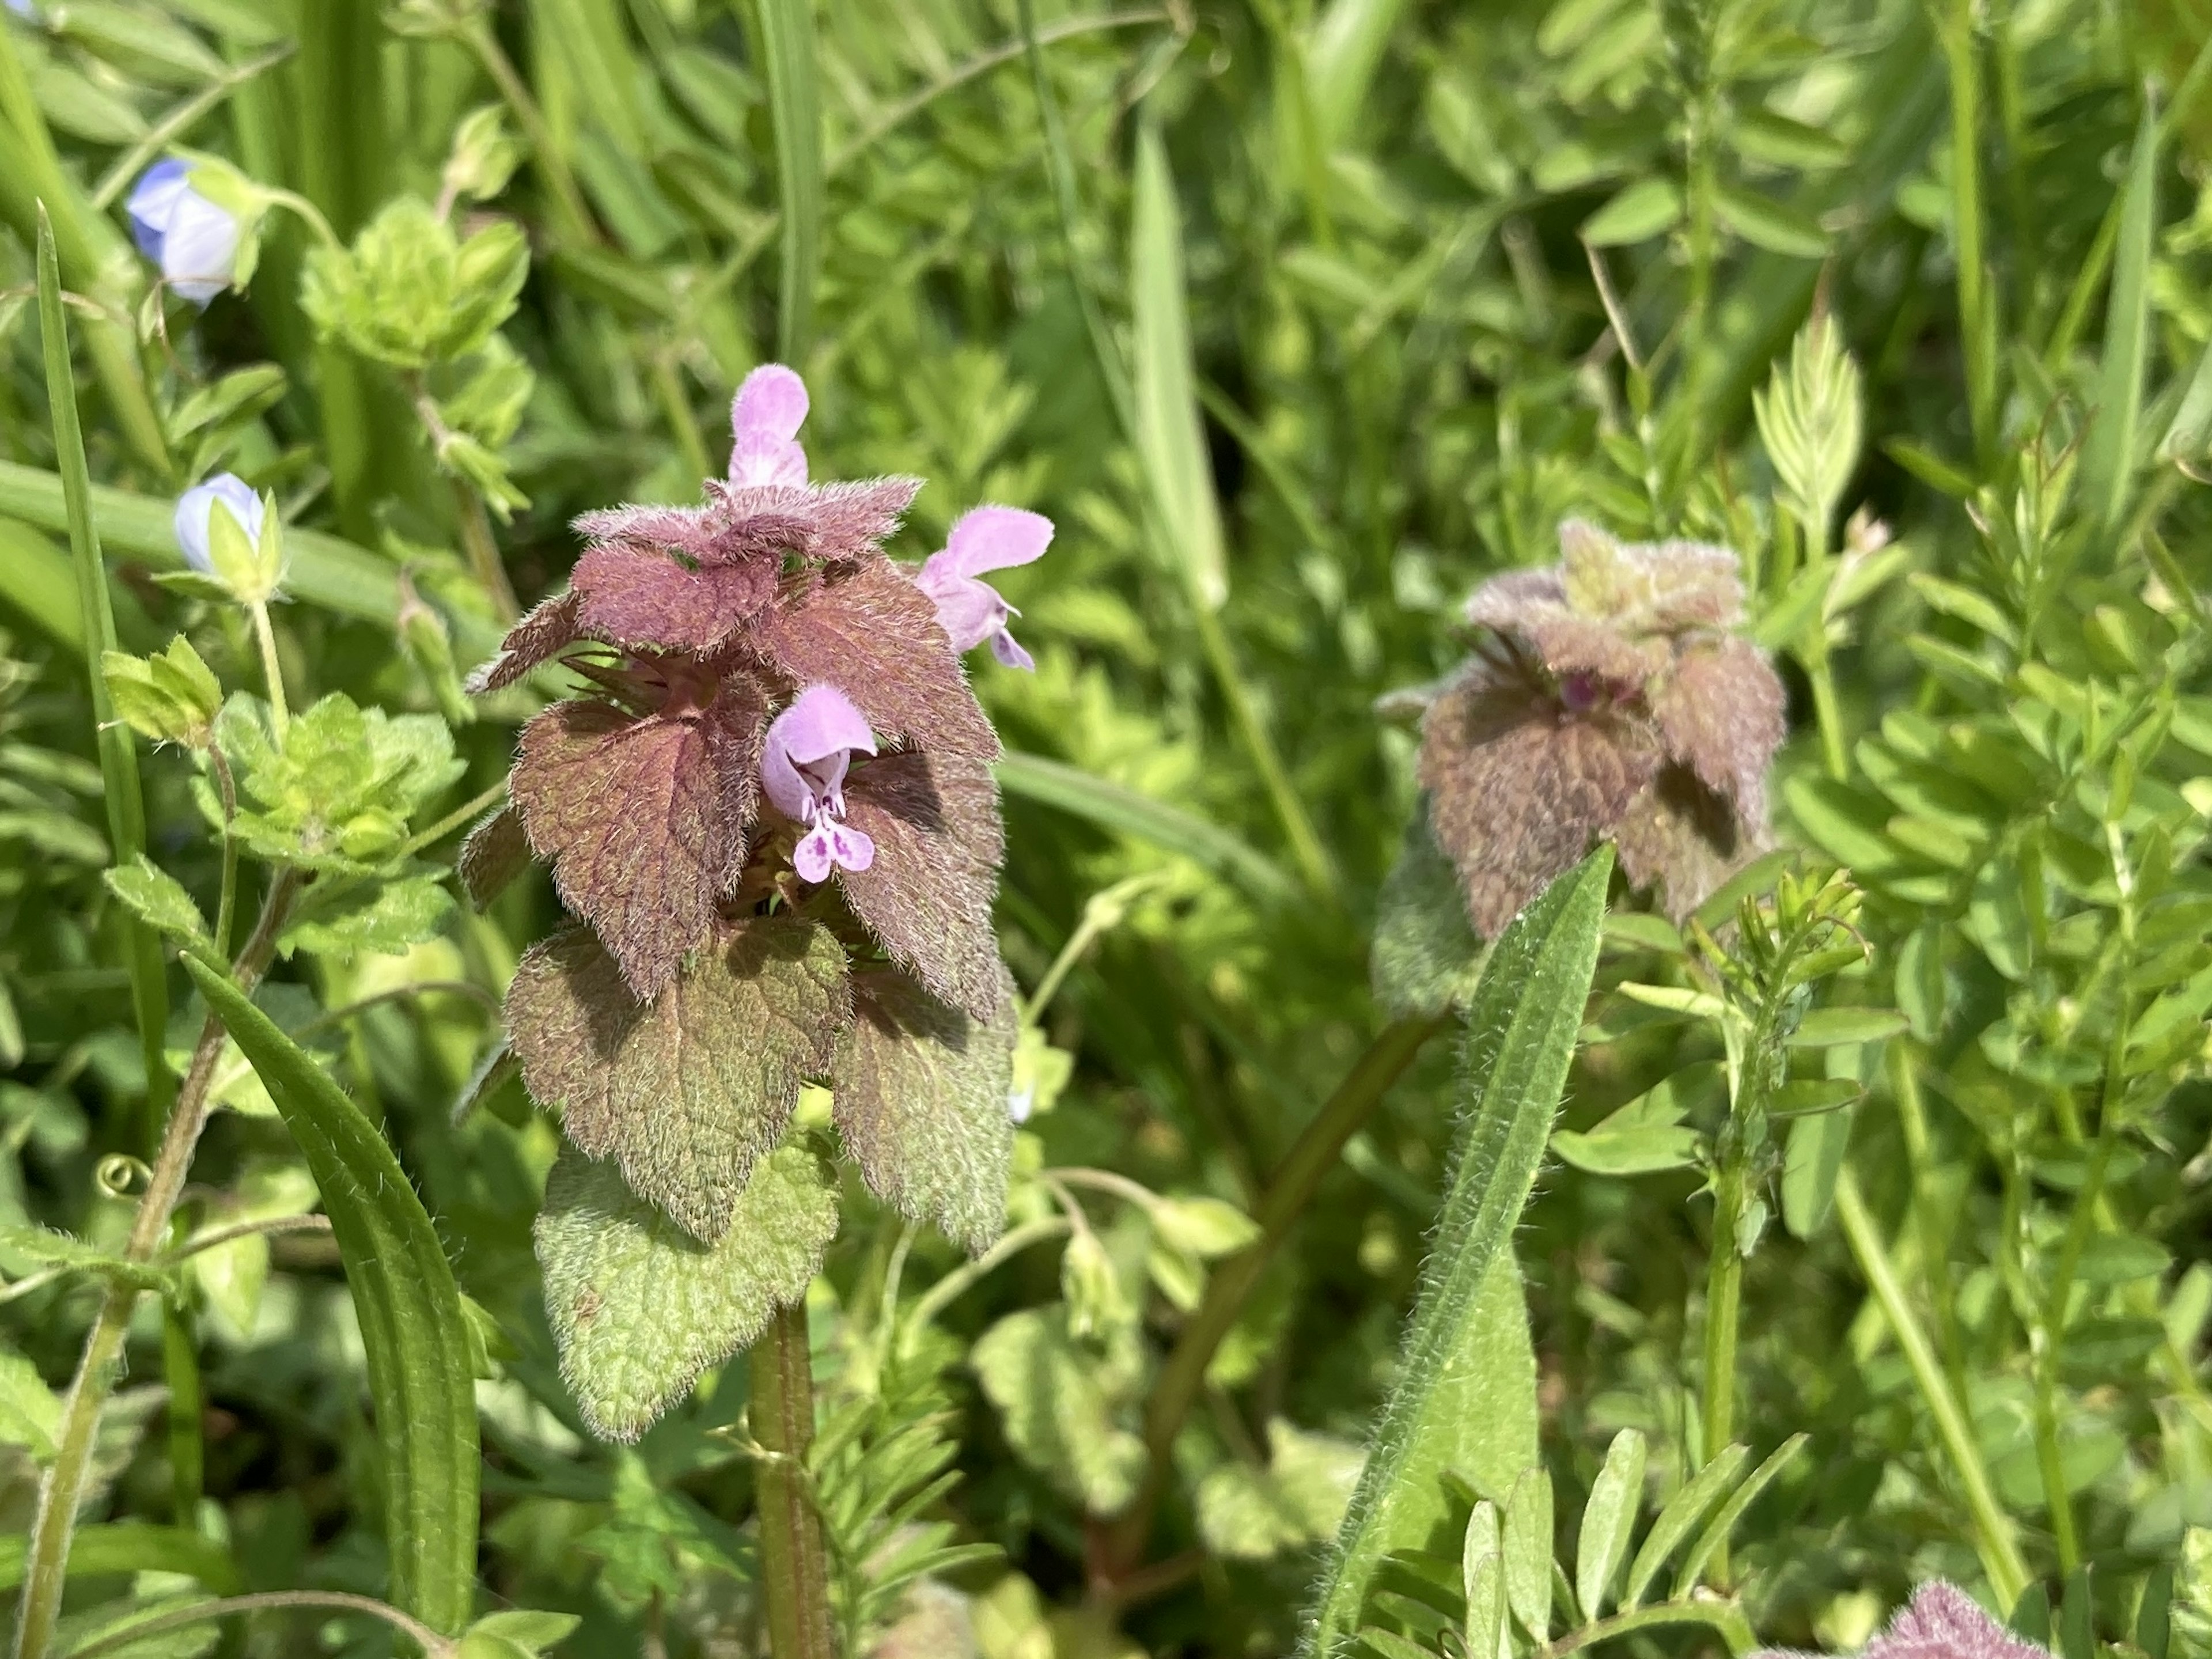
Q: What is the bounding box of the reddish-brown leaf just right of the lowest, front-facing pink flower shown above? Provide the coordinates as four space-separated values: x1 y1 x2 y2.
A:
836 752 1004 1022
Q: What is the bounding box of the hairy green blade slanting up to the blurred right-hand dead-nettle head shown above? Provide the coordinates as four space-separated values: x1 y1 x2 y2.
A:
1301 847 1612 1657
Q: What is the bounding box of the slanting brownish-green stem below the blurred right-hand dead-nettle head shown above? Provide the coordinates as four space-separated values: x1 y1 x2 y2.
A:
1106 1020 1445 1577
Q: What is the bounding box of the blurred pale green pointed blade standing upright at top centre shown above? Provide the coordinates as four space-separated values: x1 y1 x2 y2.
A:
1128 122 1230 611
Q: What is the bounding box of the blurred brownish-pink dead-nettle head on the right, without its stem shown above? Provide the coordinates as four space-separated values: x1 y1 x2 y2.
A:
1420 520 1785 938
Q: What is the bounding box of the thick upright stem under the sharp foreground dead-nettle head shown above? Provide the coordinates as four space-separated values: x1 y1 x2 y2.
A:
750 1303 836 1659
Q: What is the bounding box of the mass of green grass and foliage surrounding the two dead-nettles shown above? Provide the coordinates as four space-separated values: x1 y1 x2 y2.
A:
0 0 2212 1659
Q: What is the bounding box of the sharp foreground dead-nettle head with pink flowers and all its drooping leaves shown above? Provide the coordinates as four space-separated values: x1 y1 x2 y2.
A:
463 365 1053 1438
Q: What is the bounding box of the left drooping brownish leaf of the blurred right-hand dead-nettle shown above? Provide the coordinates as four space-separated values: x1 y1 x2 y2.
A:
1420 668 1661 938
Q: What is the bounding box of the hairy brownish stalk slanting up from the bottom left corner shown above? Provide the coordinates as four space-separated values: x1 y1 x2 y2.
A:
13 869 301 1659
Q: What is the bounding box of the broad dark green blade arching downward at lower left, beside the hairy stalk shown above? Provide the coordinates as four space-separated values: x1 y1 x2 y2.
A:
186 958 478 1635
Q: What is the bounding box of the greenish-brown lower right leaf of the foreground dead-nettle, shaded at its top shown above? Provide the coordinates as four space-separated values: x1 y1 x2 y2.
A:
834 969 1016 1252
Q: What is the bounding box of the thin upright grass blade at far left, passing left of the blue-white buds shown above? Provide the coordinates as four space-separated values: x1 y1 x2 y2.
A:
37 213 175 1139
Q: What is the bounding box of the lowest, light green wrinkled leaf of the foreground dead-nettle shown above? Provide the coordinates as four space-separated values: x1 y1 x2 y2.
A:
535 1146 838 1440
